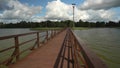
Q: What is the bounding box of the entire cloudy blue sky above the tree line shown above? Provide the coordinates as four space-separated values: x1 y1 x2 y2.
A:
0 0 120 23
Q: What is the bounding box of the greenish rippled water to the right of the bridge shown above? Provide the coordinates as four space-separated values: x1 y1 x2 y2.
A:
74 28 120 68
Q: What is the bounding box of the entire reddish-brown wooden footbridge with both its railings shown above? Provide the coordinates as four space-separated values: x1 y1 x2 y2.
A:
0 28 107 68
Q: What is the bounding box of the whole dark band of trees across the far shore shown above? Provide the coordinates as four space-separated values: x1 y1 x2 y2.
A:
0 20 120 28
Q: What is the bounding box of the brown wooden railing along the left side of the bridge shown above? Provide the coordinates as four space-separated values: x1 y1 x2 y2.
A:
0 30 62 65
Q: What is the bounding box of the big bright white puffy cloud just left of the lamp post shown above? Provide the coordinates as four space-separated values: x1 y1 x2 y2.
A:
45 0 72 20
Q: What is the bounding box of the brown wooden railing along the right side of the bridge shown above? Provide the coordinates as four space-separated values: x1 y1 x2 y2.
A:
69 29 108 68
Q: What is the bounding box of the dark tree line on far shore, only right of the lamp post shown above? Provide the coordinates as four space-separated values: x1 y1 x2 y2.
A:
75 20 120 27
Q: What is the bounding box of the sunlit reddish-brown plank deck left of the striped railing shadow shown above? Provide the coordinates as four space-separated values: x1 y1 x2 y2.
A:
9 30 66 68
